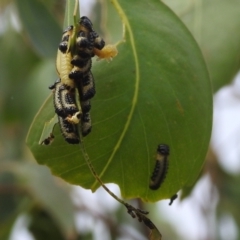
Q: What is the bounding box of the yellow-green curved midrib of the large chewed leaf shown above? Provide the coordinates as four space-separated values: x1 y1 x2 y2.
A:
91 0 140 189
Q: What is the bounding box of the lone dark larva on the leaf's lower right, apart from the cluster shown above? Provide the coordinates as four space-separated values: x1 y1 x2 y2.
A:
149 144 169 190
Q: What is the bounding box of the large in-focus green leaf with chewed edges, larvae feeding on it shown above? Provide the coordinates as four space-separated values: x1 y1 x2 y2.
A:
27 0 212 201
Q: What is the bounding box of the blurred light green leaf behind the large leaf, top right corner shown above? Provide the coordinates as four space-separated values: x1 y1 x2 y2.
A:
163 0 240 91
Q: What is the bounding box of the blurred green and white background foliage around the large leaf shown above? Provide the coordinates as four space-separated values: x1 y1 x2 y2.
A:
0 0 240 240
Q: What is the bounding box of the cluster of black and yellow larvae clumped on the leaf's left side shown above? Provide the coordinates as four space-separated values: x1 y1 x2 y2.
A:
49 16 117 144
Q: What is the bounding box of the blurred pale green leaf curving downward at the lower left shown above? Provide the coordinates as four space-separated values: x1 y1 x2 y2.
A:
1 162 75 239
